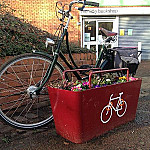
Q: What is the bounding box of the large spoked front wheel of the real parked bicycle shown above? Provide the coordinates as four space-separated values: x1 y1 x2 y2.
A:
0 53 64 128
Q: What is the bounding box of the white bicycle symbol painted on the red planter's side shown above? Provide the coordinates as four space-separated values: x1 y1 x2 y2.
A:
101 92 127 123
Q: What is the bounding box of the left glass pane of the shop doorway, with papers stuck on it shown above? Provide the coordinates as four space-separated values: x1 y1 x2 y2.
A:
84 21 96 42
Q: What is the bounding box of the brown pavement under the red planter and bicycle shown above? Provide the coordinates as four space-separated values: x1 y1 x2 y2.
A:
0 61 150 150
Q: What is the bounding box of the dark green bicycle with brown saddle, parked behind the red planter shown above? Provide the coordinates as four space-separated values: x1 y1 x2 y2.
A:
0 0 139 129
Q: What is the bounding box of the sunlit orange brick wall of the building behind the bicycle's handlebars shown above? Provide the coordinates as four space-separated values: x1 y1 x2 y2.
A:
7 0 80 42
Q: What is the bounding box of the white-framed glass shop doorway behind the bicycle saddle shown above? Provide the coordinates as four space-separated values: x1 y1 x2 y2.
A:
83 17 118 57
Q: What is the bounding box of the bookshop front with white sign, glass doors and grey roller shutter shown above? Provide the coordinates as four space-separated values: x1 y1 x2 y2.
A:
80 0 150 59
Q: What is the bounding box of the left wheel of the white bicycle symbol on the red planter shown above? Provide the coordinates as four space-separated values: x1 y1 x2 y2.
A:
101 105 112 123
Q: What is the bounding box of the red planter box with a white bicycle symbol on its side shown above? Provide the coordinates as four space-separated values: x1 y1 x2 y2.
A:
48 68 141 143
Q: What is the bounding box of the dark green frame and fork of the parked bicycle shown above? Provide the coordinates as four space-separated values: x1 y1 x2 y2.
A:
34 1 108 94
